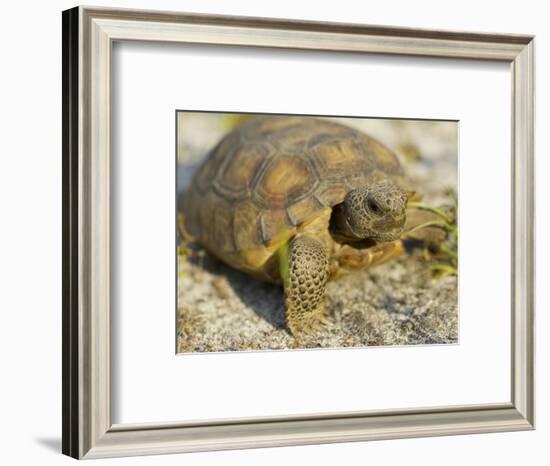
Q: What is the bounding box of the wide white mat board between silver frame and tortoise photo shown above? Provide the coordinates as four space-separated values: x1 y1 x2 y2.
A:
112 43 511 424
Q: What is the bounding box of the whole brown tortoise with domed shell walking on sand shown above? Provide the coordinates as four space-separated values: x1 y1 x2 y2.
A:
182 116 414 337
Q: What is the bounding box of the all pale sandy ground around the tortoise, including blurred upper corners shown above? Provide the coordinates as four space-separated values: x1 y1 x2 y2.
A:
177 115 458 352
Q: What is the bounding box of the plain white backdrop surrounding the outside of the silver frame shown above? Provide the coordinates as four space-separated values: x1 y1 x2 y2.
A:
0 0 550 465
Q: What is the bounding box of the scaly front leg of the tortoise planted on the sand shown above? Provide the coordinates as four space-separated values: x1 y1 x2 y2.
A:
281 235 329 338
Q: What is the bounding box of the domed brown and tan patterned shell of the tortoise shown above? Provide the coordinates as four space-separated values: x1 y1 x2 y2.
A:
183 116 408 272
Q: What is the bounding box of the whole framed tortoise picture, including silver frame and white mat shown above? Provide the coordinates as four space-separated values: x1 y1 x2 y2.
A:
63 7 534 458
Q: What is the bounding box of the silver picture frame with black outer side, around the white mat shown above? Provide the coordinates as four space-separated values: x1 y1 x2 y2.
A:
62 7 535 458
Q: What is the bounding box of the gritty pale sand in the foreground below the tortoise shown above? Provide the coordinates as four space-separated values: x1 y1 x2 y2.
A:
178 256 458 352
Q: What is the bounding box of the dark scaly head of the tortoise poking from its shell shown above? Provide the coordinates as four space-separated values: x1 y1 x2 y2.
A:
331 181 408 242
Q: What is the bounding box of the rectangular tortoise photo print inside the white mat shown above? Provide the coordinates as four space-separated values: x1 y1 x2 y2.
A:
176 111 458 353
